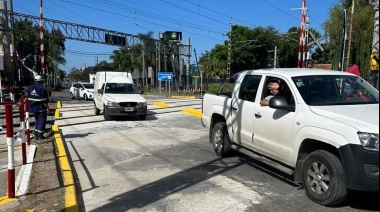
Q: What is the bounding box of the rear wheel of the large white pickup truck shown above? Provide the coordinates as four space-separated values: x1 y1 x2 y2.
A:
211 122 232 157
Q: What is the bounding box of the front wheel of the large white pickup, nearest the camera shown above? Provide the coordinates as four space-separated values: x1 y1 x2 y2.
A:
302 150 347 206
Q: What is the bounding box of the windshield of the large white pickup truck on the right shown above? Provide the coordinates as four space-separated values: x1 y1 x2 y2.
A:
292 75 379 106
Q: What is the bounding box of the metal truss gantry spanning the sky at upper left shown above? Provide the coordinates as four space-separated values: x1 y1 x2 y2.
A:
0 10 191 57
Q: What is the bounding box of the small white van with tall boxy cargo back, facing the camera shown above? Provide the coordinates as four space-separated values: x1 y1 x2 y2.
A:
94 72 147 121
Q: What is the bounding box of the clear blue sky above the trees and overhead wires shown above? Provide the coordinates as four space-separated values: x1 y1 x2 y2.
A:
12 0 340 72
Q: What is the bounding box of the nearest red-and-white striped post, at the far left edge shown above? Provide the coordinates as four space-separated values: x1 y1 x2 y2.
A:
5 104 16 198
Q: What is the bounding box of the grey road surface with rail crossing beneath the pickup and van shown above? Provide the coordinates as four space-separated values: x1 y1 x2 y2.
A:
49 88 379 211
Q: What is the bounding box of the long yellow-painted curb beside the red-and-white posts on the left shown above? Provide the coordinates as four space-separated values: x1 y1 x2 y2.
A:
52 125 79 211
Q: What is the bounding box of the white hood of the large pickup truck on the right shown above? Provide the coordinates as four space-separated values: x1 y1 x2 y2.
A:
310 104 379 133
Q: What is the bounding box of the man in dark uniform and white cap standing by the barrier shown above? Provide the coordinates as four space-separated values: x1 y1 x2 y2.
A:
28 75 49 140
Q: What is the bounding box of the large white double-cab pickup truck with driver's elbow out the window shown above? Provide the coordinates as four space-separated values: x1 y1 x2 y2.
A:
202 69 379 205
